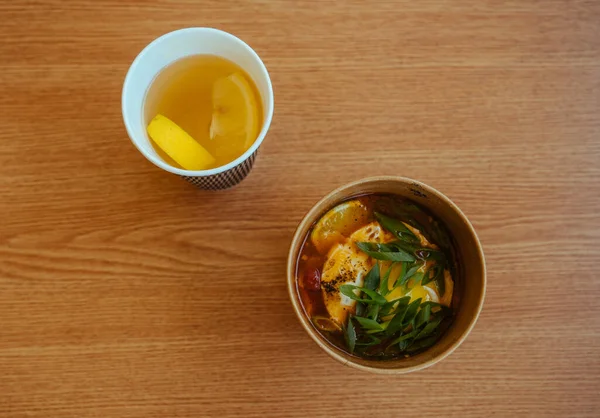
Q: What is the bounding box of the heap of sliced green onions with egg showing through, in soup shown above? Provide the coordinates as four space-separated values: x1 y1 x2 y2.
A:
342 213 453 354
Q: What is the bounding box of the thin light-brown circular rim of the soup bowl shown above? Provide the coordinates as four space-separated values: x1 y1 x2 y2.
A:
286 176 487 375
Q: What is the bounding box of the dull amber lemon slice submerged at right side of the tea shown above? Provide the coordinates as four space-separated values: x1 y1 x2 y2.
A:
210 73 259 149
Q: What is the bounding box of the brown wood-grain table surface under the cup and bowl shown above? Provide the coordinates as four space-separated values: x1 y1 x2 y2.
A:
0 0 600 418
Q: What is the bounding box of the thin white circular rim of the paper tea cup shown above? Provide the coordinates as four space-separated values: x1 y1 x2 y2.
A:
121 27 274 177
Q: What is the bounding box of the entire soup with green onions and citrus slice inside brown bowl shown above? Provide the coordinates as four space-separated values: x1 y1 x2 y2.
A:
298 195 454 359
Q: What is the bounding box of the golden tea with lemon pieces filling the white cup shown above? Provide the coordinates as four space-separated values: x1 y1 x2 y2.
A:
144 55 263 170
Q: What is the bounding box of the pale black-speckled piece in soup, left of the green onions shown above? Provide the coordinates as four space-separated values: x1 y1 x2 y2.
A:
321 222 393 324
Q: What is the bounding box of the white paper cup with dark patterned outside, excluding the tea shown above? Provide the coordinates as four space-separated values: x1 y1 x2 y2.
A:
121 28 273 190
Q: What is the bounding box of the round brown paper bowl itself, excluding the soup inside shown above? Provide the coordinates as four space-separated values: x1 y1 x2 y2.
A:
287 177 486 374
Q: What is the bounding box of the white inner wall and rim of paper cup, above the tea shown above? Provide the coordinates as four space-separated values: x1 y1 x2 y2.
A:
122 28 273 171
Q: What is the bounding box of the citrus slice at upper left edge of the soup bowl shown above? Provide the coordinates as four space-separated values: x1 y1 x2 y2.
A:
310 200 369 254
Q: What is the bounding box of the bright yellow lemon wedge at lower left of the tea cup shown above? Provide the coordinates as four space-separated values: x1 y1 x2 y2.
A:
147 115 216 170
